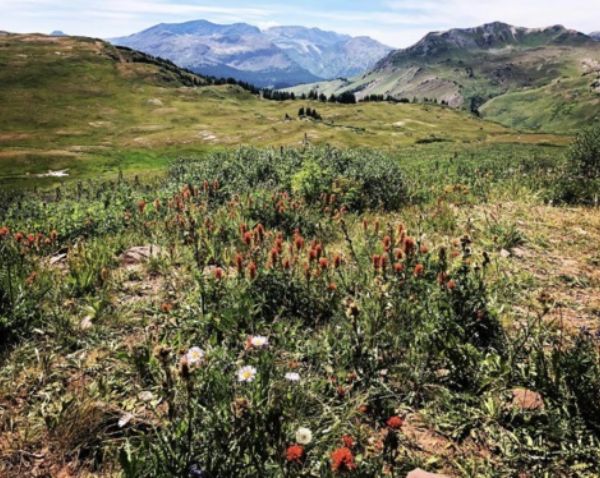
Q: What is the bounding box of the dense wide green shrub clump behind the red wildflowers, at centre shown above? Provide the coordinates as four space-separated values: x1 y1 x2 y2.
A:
171 148 408 211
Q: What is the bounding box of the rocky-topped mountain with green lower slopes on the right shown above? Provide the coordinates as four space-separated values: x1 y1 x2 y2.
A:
292 22 600 129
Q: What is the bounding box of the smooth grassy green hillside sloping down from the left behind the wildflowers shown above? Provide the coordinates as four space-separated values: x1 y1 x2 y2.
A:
0 35 568 186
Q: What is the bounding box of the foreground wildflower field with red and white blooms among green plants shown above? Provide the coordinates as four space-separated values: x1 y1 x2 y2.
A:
0 144 600 478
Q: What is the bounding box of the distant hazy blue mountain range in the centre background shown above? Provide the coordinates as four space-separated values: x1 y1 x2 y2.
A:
110 20 392 88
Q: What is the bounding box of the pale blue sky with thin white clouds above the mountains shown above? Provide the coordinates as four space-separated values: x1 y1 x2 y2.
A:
0 0 600 48
